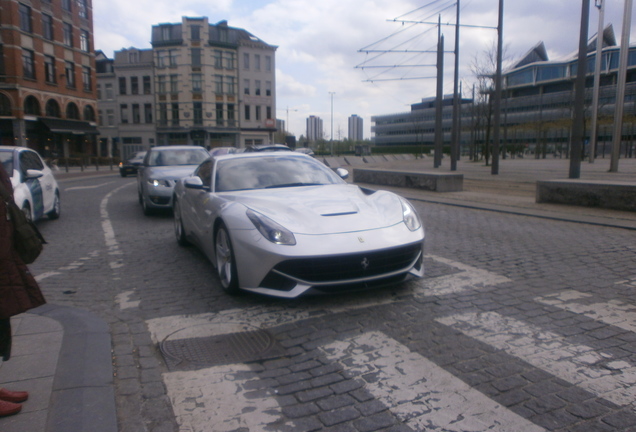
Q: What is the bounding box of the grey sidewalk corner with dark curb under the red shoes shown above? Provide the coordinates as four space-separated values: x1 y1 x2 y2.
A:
0 305 117 432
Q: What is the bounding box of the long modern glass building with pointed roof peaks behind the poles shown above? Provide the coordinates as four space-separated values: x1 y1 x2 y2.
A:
372 25 636 158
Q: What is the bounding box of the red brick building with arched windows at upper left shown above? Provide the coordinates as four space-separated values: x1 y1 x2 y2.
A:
0 0 97 156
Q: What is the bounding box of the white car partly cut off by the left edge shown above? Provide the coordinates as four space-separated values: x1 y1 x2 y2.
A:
0 146 61 221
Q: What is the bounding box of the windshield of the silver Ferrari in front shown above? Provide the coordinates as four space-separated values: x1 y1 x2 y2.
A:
215 154 343 192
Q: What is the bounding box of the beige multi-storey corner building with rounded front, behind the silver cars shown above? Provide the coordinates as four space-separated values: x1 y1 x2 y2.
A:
151 17 277 147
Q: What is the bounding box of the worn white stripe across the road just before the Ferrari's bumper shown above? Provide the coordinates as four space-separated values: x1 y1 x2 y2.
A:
147 255 510 343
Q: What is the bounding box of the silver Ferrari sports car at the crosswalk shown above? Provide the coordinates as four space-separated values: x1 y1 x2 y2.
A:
173 152 424 298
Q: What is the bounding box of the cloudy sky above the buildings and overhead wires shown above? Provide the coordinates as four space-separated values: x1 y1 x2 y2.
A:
93 0 636 139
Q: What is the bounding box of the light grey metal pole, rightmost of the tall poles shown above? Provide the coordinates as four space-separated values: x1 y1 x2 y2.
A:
609 0 632 172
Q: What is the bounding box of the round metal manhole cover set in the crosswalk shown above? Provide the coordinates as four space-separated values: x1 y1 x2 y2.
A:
160 330 285 370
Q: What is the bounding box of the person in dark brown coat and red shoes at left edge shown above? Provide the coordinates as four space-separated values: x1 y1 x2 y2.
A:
0 163 46 417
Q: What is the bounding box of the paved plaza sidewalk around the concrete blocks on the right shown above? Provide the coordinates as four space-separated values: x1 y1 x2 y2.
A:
356 154 636 230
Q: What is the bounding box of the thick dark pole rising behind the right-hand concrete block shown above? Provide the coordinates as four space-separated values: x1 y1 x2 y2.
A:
570 0 590 178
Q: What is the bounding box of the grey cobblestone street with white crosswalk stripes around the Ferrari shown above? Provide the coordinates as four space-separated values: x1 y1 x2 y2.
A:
7 162 636 432
